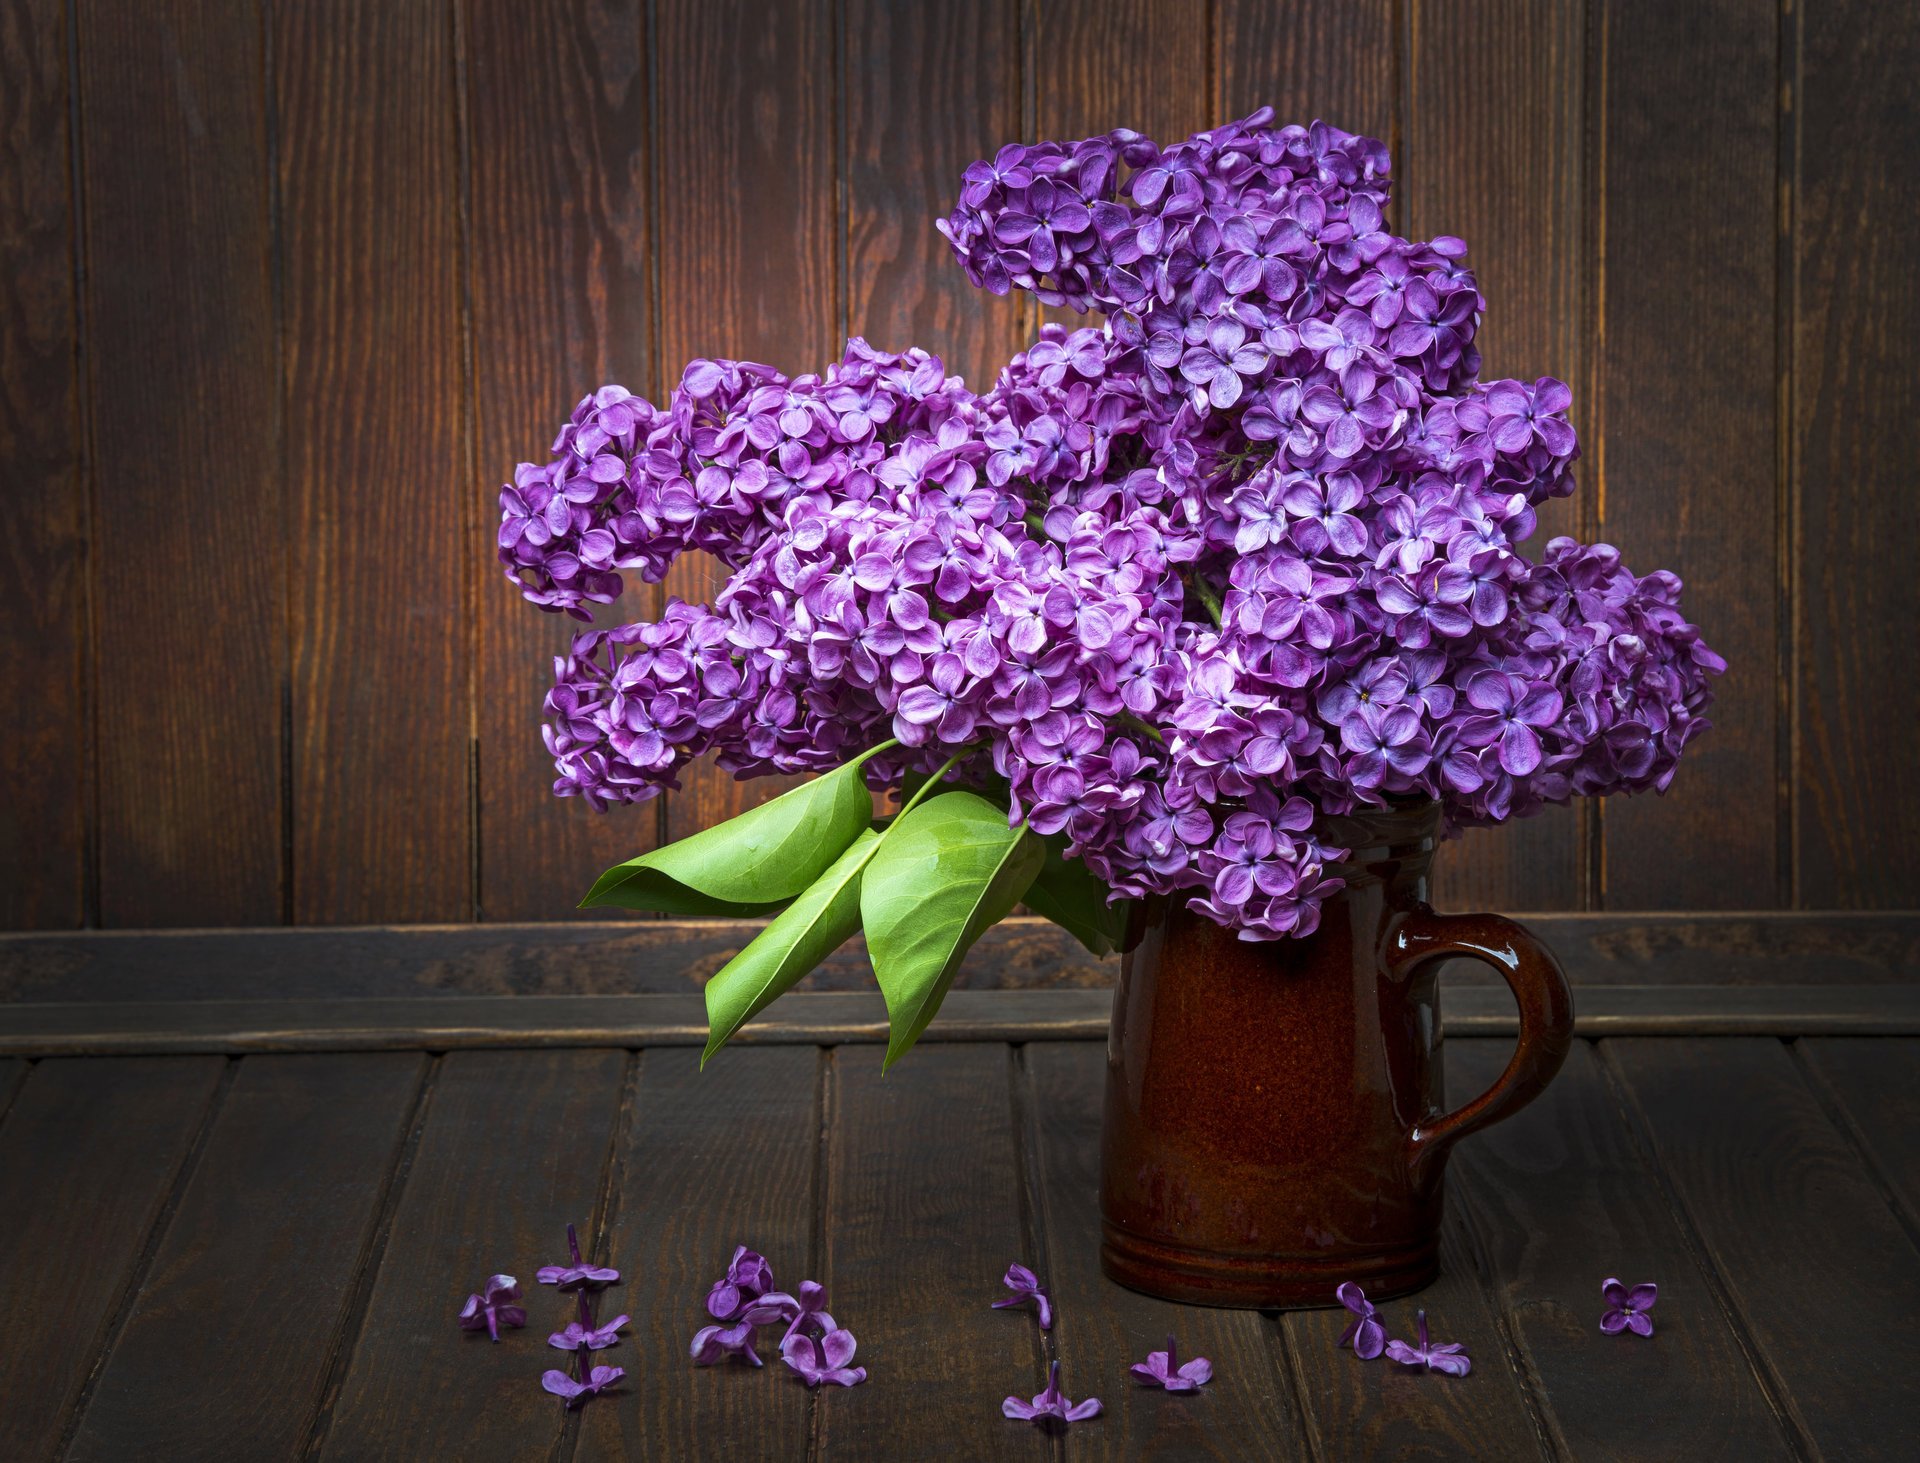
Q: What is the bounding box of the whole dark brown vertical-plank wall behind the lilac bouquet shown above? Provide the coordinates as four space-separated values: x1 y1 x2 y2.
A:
0 0 1920 929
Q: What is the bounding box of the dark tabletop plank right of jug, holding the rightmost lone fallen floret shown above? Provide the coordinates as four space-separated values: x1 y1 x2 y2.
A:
1446 1041 1793 1463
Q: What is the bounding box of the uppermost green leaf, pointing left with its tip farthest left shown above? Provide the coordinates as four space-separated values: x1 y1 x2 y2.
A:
580 749 877 918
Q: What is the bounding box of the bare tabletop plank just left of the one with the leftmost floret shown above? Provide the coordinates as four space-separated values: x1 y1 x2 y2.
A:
67 1052 426 1463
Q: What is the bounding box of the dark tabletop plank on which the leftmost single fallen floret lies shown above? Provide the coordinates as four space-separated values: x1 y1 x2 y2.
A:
321 1050 628 1463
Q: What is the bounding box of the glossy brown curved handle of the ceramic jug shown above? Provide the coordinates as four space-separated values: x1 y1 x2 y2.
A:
1386 904 1572 1179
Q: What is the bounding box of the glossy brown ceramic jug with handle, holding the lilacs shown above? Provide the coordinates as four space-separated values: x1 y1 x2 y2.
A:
1100 804 1572 1306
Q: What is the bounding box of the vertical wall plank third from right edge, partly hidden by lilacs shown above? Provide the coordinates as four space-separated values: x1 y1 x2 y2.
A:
1394 0 1597 910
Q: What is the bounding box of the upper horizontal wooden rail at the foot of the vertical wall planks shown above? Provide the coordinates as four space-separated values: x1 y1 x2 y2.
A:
0 910 1920 1002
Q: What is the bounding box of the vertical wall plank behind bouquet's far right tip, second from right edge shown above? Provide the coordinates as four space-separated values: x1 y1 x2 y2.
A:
1584 0 1781 910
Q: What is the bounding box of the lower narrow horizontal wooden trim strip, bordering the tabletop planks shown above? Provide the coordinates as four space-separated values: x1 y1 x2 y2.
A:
0 985 1920 1056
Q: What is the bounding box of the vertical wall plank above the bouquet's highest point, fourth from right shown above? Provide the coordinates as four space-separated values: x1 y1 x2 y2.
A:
1213 0 1400 145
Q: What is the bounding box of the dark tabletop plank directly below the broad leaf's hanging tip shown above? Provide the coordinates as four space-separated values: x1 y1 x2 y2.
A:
814 1046 1052 1461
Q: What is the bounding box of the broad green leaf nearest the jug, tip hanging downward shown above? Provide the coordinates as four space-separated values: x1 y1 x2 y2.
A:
860 791 1046 1067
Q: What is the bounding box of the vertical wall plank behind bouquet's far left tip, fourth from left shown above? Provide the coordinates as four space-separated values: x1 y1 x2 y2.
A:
463 0 659 920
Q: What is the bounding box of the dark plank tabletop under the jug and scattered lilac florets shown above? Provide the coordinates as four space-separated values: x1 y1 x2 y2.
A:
0 993 1920 1461
